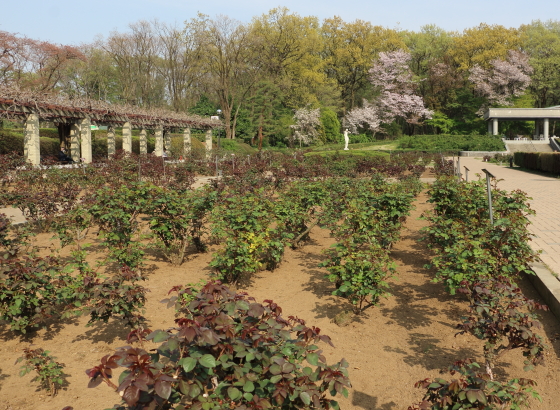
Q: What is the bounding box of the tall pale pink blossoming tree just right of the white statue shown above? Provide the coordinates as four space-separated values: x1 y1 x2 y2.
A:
346 50 432 133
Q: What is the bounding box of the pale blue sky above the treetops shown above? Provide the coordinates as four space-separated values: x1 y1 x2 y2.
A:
0 0 560 45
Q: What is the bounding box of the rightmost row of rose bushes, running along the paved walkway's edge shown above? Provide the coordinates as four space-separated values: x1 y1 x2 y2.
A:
410 167 547 410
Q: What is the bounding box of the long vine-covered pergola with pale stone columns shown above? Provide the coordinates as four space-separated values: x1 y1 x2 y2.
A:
0 97 222 165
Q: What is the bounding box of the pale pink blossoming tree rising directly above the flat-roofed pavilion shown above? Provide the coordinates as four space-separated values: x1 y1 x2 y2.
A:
469 50 533 114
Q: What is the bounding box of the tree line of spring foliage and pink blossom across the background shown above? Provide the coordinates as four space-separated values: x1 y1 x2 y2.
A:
0 8 560 145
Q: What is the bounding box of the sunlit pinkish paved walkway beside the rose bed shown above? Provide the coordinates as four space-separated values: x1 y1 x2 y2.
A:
452 157 560 275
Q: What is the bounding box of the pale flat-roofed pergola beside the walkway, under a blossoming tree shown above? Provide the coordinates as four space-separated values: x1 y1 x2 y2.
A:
484 106 560 139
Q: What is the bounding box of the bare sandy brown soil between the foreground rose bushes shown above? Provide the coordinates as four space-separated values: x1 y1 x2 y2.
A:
0 195 560 410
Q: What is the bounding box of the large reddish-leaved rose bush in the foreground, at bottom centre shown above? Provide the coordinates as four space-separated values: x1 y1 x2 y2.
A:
86 283 350 410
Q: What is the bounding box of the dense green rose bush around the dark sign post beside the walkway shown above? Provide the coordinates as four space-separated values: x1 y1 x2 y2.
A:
422 177 537 294
